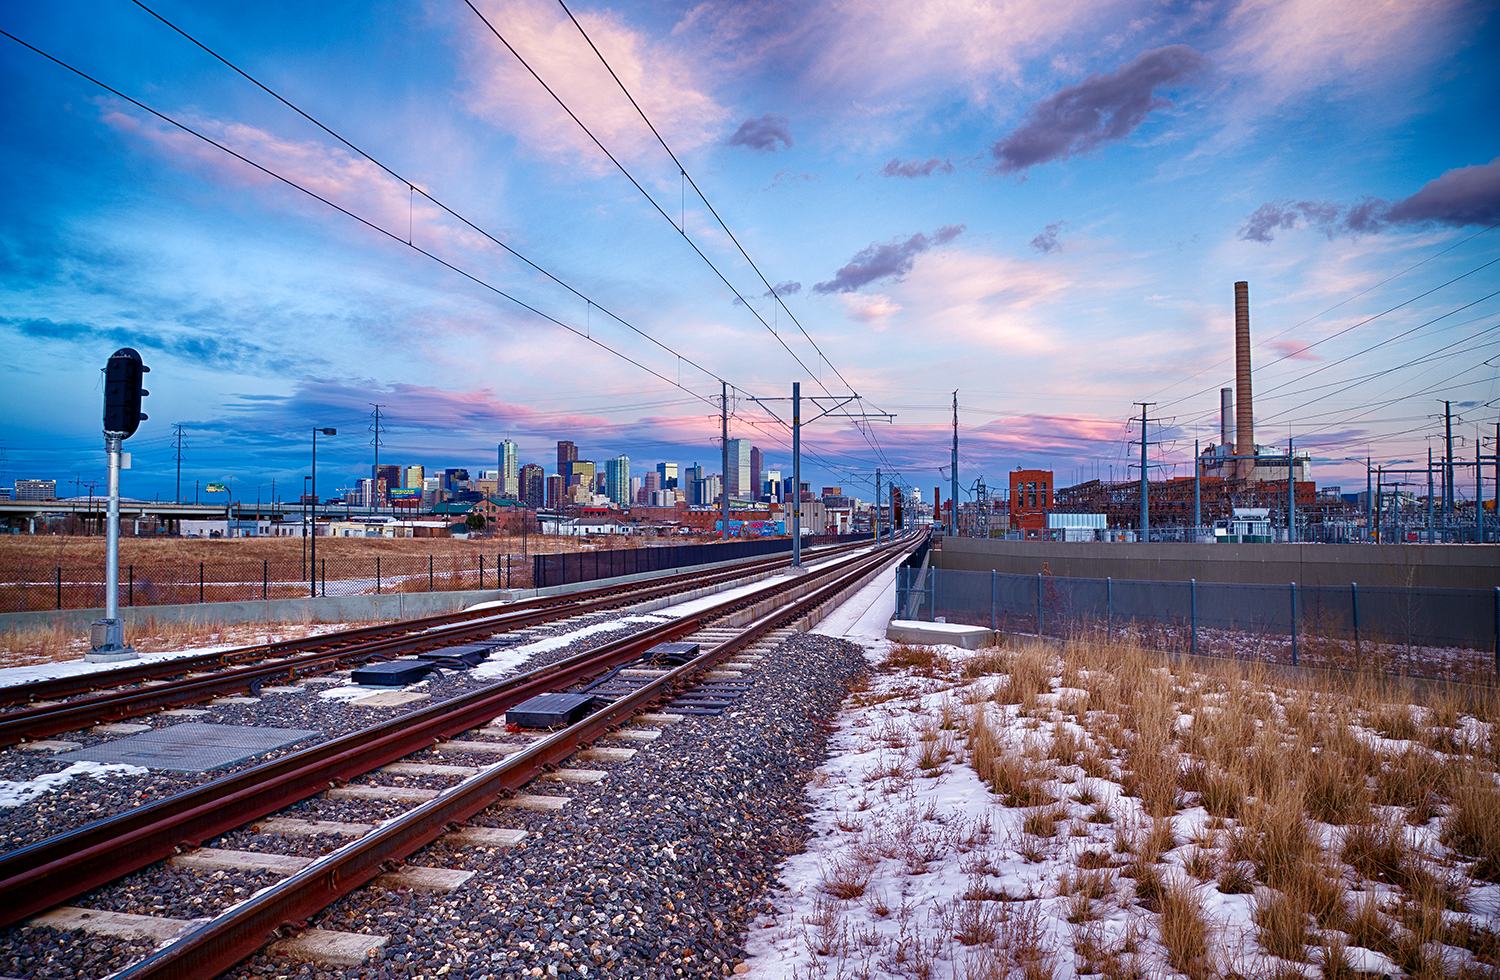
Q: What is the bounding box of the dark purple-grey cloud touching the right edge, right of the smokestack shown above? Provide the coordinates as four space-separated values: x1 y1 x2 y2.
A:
1239 158 1500 243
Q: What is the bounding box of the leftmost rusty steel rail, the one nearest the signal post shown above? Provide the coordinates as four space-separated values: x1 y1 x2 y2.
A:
0 542 863 705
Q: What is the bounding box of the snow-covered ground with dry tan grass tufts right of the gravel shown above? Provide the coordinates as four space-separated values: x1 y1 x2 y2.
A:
747 572 1500 980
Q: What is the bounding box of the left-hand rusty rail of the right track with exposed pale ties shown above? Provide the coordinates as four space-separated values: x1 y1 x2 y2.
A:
0 540 894 926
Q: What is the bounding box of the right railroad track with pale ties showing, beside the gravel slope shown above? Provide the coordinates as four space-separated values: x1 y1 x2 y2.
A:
0 542 912 980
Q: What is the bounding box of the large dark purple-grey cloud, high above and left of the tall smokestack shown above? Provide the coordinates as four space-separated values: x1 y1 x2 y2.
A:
990 44 1209 174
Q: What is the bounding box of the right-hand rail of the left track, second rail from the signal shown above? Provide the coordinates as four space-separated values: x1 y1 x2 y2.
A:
0 543 870 747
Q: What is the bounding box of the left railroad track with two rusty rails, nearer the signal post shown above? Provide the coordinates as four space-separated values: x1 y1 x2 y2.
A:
0 534 864 747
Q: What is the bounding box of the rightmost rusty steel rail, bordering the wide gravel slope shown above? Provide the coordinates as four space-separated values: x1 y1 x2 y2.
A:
111 548 894 980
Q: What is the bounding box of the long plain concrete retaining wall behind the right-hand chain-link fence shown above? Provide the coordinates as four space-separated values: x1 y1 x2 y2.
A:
933 537 1500 588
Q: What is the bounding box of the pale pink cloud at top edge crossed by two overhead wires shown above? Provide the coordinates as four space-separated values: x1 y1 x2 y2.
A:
455 0 729 170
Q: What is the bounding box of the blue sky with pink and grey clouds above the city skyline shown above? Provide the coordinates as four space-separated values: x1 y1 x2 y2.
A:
0 0 1500 497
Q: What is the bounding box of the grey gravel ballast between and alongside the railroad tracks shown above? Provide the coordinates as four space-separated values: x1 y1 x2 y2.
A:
0 627 866 980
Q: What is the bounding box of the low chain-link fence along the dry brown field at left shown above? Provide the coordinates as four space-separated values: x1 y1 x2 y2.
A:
0 551 531 612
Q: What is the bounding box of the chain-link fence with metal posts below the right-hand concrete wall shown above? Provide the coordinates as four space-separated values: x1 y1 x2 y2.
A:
897 567 1500 681
